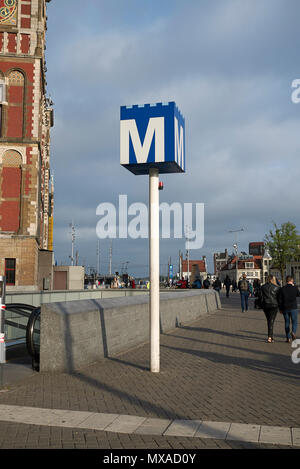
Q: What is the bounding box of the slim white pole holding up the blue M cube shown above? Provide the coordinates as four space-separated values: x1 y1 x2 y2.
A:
149 168 160 373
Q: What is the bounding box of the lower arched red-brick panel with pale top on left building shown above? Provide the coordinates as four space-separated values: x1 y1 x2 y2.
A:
0 150 22 233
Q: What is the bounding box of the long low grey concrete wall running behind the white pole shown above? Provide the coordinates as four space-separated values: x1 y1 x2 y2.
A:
40 290 221 372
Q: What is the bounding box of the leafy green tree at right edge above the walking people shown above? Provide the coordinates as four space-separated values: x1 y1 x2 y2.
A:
264 222 300 280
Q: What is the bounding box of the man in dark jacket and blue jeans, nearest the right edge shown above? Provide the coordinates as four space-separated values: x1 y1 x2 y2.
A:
279 275 300 342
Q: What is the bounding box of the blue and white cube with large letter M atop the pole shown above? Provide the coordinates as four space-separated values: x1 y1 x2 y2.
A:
120 102 185 174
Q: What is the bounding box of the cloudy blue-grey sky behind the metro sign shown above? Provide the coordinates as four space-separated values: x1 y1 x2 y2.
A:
46 0 300 277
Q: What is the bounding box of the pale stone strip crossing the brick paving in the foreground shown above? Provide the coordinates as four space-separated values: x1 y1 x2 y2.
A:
0 404 300 449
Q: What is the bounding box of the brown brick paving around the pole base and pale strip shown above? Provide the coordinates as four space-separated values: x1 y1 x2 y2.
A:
0 294 300 449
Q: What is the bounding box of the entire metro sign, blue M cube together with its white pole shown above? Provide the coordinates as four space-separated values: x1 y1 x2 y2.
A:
120 101 185 373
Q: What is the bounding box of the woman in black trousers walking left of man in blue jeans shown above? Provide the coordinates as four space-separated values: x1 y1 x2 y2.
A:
260 275 280 343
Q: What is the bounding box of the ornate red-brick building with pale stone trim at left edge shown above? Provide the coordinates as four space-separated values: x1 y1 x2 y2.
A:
0 0 53 290
